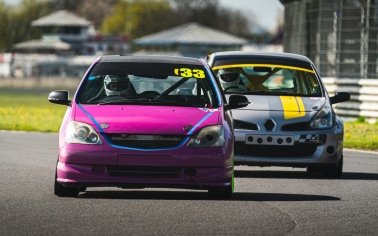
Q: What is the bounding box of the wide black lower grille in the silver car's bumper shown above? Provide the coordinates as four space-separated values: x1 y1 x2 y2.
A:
235 142 318 157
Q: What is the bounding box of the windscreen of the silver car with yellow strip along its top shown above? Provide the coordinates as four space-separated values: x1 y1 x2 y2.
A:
213 64 322 97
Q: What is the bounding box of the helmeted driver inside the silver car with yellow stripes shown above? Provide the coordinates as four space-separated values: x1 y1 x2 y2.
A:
217 68 248 92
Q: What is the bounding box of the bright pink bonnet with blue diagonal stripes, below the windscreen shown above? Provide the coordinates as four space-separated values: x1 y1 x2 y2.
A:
75 105 219 135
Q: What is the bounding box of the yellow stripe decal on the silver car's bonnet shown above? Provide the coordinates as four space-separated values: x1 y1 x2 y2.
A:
280 96 305 120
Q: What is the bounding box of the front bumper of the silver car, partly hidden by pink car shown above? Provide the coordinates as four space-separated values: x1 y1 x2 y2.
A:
235 127 343 167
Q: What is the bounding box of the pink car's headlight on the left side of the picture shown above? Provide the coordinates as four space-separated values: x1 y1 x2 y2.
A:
65 121 102 144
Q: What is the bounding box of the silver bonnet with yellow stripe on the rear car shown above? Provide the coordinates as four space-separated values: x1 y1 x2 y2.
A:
232 95 326 123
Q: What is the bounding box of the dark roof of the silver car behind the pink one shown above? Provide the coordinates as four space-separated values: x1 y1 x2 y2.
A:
208 51 313 70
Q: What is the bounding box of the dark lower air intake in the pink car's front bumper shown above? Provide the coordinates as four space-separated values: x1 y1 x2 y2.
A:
107 165 181 179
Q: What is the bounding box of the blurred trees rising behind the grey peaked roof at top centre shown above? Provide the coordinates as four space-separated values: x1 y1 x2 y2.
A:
100 0 256 38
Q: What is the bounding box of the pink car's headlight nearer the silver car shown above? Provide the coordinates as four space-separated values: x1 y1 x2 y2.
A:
188 125 225 147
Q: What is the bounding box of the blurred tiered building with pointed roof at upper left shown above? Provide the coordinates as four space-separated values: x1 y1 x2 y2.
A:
9 10 130 77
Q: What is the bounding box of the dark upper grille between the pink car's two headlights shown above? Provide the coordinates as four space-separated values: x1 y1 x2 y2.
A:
105 134 184 149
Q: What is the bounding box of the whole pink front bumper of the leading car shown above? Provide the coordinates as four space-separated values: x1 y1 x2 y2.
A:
56 144 233 190
